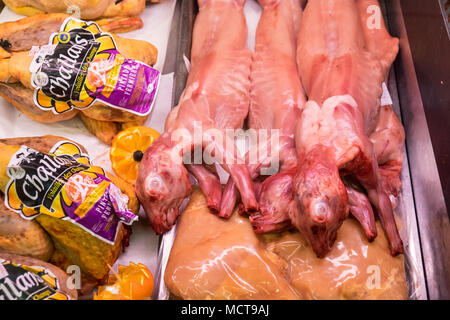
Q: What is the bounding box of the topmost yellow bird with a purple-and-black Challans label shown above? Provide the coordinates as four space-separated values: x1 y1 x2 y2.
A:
0 13 160 144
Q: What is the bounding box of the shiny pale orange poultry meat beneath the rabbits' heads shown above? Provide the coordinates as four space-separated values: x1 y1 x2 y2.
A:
164 188 408 299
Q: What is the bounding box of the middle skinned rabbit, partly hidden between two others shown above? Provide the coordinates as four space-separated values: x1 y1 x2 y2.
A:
249 0 306 233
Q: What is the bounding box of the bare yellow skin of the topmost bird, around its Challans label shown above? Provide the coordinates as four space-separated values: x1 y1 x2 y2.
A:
0 14 158 144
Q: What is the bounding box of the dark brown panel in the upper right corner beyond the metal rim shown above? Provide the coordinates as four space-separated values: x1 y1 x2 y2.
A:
400 0 450 209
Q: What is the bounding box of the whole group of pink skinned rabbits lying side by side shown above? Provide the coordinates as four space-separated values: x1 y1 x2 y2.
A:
137 0 404 257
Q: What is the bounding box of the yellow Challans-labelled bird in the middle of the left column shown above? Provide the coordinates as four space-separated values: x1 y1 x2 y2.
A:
0 136 139 293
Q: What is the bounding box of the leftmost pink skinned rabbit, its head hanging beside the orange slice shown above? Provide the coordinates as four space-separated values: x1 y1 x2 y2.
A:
136 0 257 234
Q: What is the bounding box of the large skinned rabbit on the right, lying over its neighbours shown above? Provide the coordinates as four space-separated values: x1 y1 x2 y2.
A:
290 0 403 257
